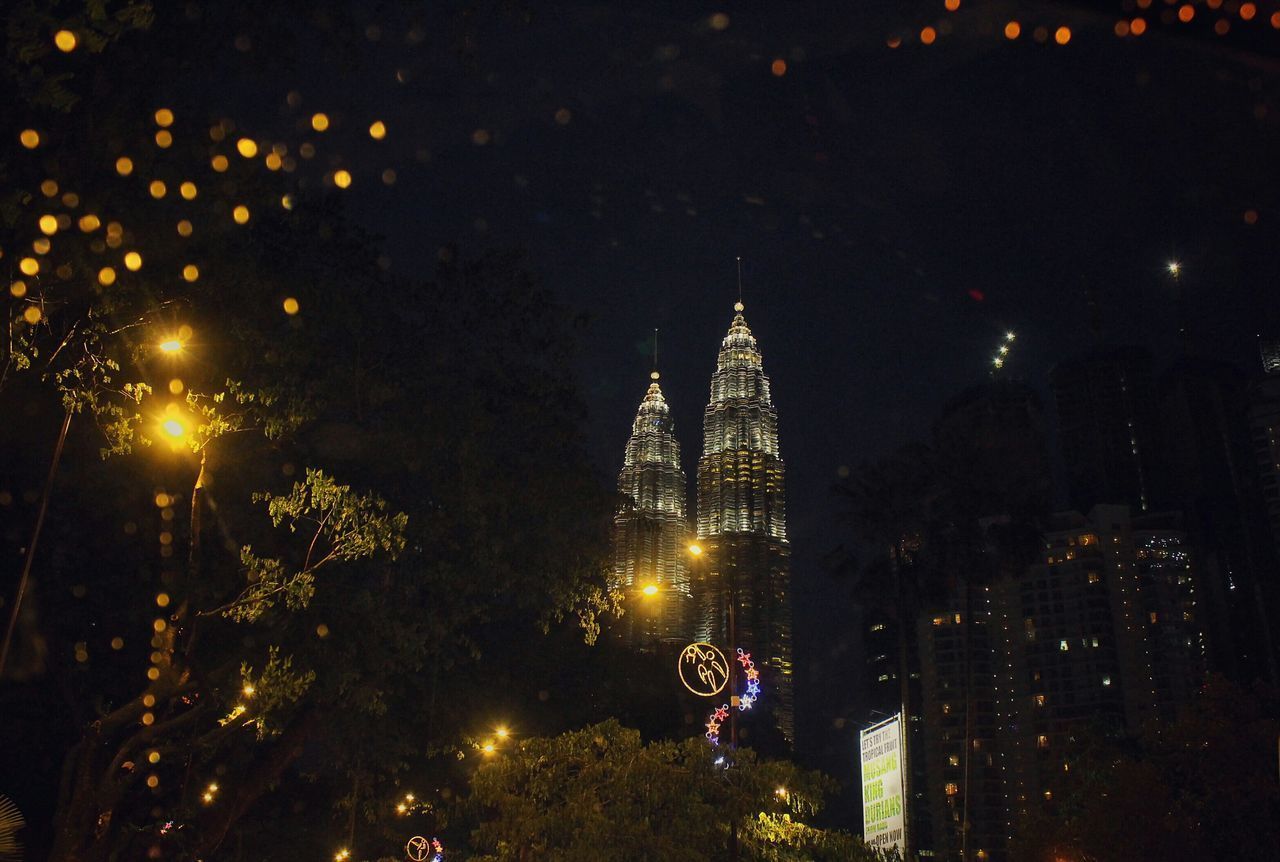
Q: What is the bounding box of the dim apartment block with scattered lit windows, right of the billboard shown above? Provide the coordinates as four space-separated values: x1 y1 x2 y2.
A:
916 506 1204 859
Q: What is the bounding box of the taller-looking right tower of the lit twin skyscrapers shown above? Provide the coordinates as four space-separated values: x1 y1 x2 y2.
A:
694 302 795 740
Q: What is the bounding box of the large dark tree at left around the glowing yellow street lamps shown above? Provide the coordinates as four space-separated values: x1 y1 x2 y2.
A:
0 3 619 859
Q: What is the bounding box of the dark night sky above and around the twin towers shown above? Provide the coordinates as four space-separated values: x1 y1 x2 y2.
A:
212 0 1280 768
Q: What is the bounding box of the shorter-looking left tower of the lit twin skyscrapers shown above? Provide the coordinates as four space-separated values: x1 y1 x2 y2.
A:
612 371 694 649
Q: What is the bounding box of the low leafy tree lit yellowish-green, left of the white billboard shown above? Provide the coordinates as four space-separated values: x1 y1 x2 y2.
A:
468 720 883 862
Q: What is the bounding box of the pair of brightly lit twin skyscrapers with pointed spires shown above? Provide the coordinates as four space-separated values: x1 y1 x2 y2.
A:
612 302 795 740
